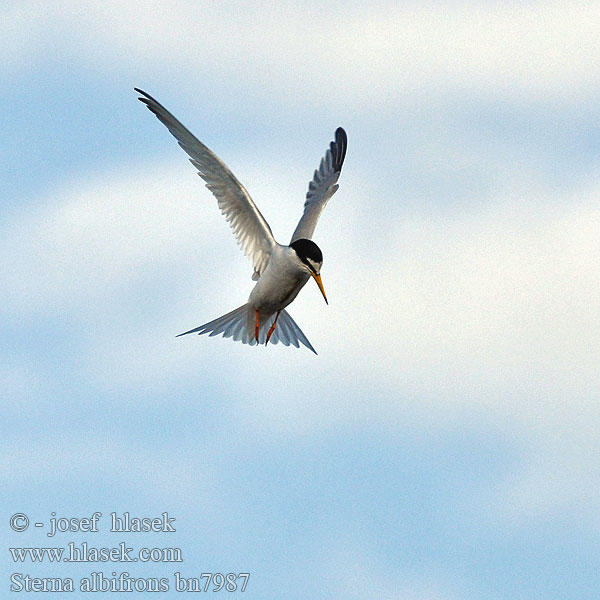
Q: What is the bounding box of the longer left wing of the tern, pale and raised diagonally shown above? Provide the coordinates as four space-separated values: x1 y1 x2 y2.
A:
134 88 276 279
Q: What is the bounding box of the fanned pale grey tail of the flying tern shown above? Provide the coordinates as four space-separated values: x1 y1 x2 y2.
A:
177 304 317 354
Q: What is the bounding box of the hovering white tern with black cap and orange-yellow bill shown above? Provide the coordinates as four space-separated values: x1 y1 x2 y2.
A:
134 88 348 354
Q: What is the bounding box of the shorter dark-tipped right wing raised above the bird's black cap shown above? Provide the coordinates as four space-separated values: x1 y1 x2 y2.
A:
290 127 348 243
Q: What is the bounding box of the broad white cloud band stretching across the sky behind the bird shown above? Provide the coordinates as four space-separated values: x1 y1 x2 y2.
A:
0 57 600 520
